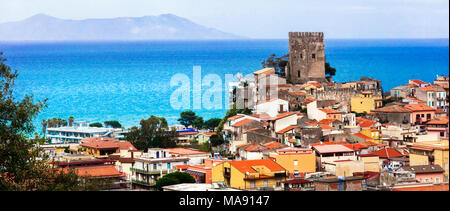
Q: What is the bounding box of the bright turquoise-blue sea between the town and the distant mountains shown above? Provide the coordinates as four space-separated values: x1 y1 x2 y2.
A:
0 39 449 131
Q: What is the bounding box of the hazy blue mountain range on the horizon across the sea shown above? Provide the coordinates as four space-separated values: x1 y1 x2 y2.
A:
0 14 245 41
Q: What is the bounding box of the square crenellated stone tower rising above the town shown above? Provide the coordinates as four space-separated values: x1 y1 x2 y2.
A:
287 32 327 84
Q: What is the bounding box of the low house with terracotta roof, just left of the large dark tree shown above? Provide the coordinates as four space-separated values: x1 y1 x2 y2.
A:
80 137 137 158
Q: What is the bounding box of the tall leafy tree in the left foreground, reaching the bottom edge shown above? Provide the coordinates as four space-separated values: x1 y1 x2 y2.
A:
0 52 107 191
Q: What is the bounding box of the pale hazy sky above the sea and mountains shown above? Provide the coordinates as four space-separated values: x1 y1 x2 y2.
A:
0 0 449 39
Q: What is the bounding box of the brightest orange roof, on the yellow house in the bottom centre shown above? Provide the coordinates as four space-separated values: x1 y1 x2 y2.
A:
229 159 286 174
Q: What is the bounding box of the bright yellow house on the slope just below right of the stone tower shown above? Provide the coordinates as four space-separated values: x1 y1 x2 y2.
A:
351 92 383 113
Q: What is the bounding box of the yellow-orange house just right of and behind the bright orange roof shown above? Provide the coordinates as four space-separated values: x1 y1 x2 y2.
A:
269 148 316 178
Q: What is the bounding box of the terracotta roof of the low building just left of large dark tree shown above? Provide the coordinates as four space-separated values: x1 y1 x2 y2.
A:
81 137 137 150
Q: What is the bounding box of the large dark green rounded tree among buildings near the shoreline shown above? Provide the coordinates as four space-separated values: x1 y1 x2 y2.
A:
126 116 177 150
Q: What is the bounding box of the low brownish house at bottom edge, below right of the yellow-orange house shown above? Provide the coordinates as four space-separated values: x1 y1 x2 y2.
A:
314 176 364 191
